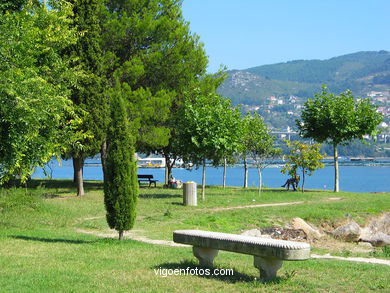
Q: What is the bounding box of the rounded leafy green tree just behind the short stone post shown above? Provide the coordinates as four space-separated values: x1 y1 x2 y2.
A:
178 89 240 199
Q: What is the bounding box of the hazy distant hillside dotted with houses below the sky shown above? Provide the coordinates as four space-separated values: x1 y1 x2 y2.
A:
219 51 390 105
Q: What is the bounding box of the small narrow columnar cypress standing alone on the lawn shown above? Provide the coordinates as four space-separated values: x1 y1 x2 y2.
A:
104 95 138 240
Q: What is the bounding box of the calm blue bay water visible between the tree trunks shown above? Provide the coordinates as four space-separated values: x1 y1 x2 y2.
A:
33 161 390 192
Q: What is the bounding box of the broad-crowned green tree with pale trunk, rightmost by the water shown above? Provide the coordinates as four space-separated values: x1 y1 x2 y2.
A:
296 86 382 192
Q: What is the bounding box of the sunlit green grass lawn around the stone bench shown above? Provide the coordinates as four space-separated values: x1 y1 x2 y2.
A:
0 180 390 292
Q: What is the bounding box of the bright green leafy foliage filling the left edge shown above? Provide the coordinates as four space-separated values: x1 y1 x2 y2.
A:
0 3 80 182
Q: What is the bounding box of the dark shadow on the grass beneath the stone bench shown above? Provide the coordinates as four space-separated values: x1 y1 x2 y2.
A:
153 260 285 284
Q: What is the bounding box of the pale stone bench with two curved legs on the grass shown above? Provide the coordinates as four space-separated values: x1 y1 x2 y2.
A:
173 230 310 281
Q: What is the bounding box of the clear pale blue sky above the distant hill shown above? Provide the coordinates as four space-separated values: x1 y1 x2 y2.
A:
182 0 390 72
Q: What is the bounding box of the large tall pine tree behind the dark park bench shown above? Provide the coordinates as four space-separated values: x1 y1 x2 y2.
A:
102 0 207 183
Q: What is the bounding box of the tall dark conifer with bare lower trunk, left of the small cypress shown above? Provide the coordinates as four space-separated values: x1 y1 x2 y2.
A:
64 0 109 196
